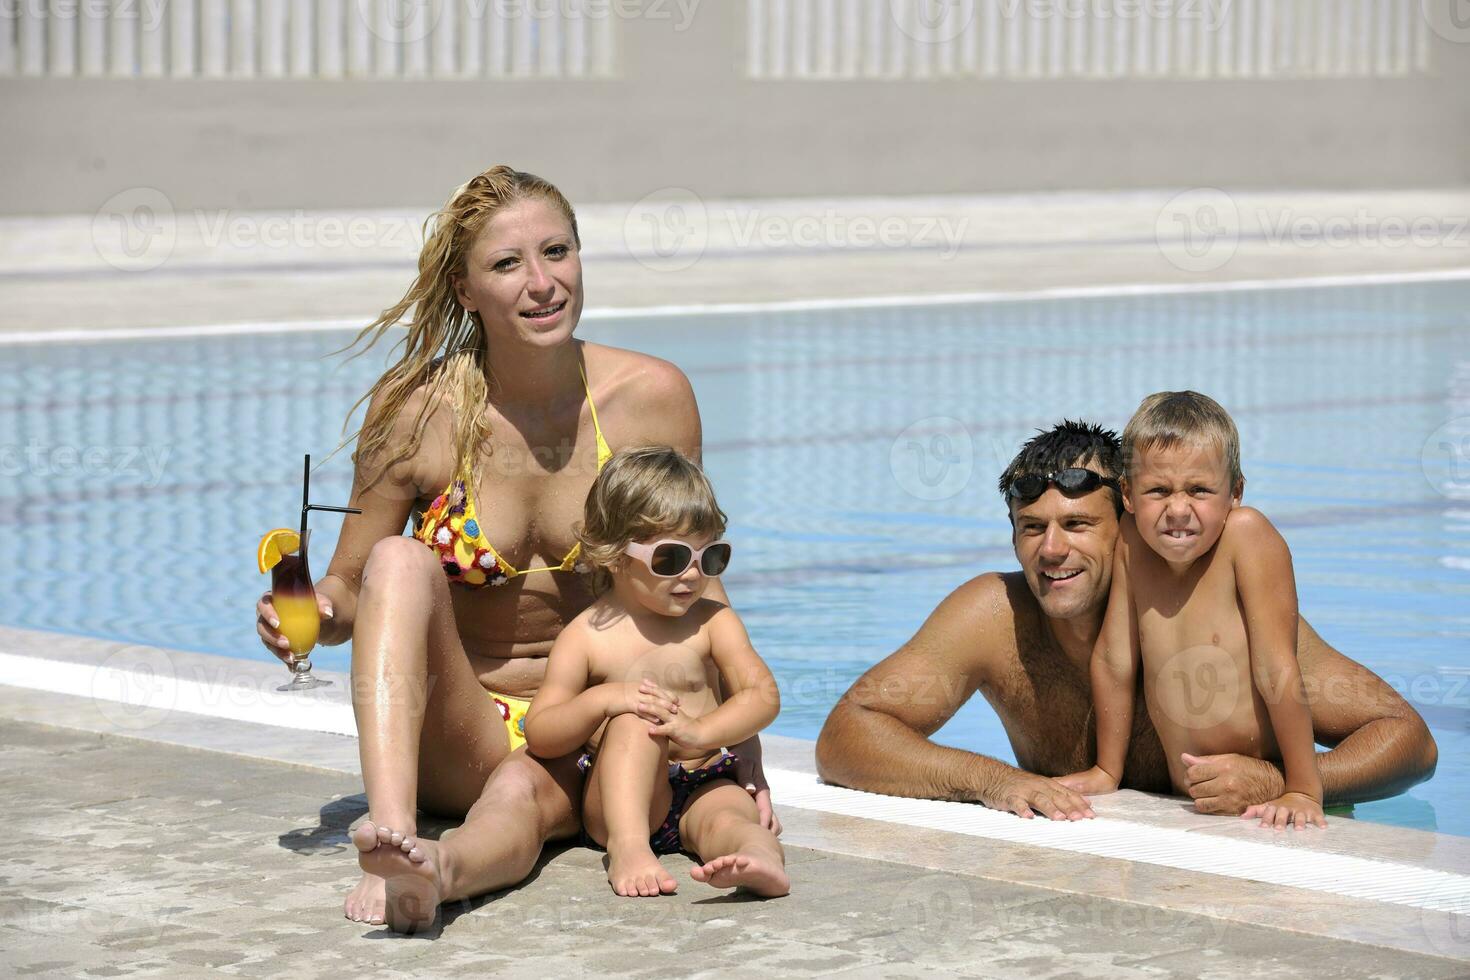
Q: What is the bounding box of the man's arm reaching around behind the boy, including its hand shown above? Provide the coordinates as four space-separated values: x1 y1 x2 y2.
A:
1186 619 1439 814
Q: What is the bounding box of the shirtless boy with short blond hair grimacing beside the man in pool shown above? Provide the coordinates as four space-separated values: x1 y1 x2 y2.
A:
1061 391 1327 829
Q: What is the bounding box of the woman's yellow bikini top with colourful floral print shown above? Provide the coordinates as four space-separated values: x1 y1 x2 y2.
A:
413 366 613 588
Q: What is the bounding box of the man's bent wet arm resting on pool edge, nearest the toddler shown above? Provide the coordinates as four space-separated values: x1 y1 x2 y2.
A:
816 573 1092 820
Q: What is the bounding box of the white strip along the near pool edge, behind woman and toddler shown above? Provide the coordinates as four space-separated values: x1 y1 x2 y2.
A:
0 651 1470 915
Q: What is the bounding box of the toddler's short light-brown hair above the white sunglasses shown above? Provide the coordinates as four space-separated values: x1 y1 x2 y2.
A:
573 445 728 592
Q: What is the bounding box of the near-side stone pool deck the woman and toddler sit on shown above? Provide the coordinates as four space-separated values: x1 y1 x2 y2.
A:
0 629 1470 977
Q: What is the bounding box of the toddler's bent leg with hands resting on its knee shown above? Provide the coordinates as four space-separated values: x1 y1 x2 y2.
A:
584 714 678 898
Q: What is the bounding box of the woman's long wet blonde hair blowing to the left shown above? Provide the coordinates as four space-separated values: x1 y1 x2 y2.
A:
338 166 582 485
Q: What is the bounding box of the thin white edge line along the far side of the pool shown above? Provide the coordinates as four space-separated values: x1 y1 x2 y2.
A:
0 267 1470 347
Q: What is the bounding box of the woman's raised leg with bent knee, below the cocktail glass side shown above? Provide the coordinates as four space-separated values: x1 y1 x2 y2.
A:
344 538 510 921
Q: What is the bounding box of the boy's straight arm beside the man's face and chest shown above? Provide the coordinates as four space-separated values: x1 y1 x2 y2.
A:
1057 531 1139 795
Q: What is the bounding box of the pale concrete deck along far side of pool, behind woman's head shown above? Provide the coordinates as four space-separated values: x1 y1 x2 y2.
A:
0 188 1470 342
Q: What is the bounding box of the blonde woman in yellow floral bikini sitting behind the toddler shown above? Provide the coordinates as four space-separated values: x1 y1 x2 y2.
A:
256 166 778 932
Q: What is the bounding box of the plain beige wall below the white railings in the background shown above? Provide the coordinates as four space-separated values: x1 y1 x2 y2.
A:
0 3 1470 215
